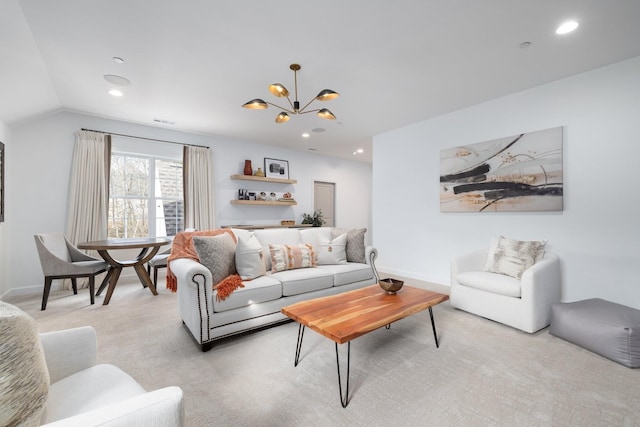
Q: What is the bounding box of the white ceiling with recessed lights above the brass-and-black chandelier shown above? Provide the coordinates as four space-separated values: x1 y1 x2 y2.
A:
0 0 640 161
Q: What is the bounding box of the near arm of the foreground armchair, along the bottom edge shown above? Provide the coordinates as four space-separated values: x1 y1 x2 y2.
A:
45 386 184 427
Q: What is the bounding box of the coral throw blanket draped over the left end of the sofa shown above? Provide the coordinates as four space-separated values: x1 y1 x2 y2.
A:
167 229 244 301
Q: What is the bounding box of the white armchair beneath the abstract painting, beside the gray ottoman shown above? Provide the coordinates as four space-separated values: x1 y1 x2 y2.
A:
450 248 561 333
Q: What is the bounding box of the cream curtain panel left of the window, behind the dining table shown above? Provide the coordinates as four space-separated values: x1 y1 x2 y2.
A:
66 130 111 252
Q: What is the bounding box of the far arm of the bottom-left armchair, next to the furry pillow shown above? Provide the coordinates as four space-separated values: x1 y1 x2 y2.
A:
40 326 98 384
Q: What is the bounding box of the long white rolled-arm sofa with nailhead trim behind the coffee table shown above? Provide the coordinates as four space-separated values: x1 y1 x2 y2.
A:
169 227 377 351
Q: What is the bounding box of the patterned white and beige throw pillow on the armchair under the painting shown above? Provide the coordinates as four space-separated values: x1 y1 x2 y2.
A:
488 237 546 279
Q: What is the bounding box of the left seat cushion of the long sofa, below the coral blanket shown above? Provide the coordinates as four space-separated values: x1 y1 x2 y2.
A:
212 275 282 312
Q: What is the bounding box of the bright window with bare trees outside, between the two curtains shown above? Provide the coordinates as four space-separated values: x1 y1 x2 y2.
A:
108 153 184 238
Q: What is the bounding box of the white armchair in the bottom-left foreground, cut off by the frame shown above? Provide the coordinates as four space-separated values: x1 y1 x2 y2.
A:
40 326 184 427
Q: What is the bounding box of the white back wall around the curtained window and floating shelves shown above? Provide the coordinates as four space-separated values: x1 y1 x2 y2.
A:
0 112 371 297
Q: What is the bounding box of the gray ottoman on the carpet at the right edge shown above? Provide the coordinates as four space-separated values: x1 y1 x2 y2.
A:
549 298 640 368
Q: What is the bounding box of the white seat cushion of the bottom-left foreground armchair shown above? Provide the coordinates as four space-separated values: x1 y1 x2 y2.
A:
42 365 145 423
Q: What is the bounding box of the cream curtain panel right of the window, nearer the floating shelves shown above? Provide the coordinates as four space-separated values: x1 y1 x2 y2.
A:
183 145 216 230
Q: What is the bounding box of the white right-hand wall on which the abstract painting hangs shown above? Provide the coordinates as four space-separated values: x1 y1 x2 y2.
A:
373 57 640 308
